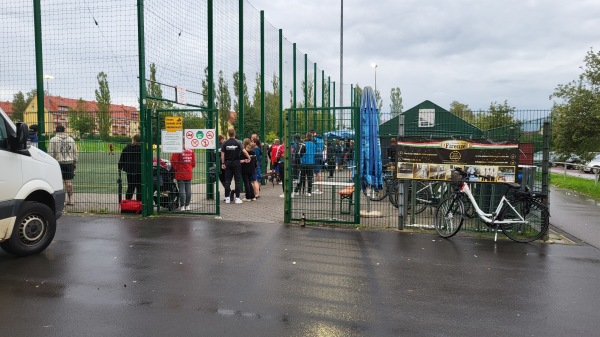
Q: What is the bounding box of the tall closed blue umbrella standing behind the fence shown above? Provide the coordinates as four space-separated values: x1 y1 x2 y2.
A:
360 87 383 190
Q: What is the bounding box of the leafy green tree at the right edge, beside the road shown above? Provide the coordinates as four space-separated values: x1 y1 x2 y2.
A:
550 49 600 158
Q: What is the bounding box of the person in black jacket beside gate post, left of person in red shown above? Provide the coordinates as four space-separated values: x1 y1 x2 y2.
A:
119 134 142 201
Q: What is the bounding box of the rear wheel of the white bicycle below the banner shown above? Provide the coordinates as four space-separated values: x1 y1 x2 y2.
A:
499 199 550 242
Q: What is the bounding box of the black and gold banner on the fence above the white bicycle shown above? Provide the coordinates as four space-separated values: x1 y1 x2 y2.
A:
396 138 519 182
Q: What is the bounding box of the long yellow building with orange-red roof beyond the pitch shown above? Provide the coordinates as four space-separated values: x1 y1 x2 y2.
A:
23 96 140 137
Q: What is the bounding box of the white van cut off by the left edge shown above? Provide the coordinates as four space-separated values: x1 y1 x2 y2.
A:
0 109 65 256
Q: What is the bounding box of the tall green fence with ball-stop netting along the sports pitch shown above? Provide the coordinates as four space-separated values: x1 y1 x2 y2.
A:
0 0 335 215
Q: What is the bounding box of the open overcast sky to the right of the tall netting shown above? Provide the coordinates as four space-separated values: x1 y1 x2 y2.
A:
249 0 600 111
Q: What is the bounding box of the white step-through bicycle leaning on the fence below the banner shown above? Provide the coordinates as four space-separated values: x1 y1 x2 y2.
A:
435 168 550 242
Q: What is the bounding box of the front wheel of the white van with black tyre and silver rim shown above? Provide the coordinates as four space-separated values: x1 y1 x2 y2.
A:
0 201 56 256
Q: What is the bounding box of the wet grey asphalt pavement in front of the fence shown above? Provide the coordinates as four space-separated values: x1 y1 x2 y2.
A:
0 211 600 337
